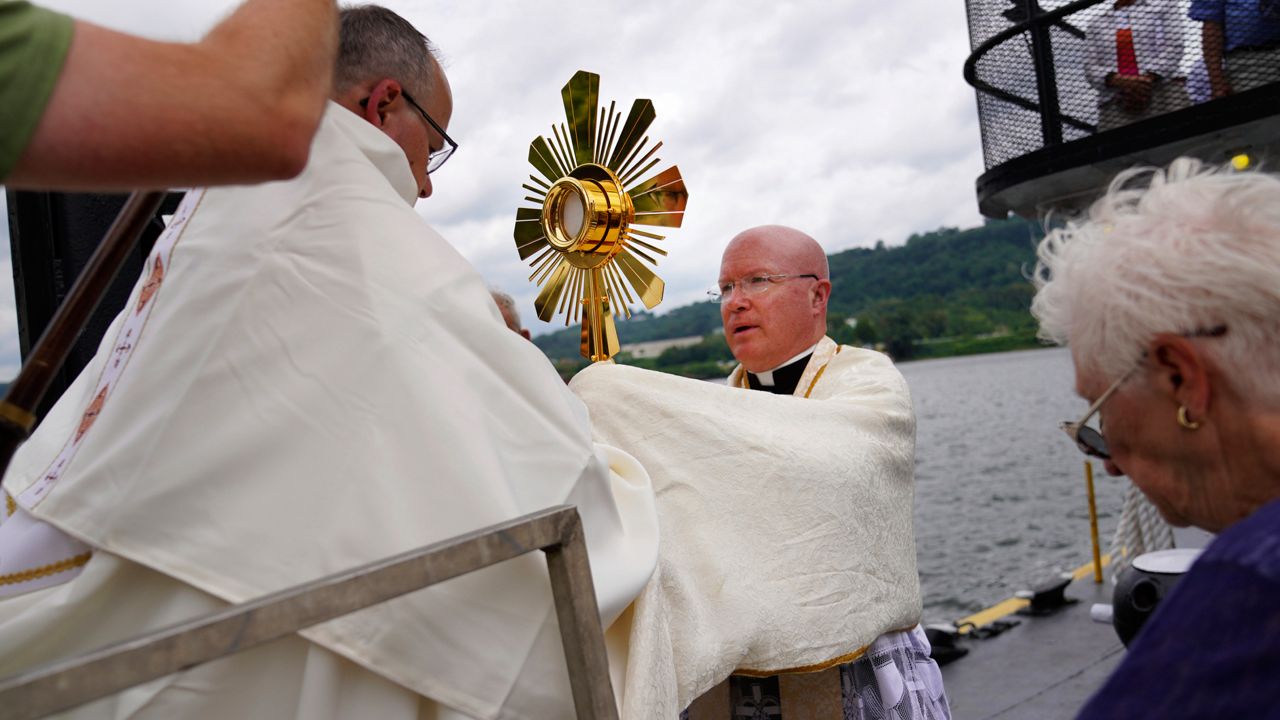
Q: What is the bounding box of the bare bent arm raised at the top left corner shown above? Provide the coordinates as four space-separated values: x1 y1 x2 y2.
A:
5 0 338 190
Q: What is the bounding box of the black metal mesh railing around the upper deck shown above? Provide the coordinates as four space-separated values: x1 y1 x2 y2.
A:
966 0 1280 169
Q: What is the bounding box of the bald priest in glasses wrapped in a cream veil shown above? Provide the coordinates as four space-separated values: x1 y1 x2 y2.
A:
571 225 950 720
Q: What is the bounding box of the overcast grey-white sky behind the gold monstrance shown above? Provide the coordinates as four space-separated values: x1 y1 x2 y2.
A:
0 0 983 378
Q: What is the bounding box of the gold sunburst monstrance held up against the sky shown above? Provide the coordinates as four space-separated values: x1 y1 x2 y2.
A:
516 70 689 361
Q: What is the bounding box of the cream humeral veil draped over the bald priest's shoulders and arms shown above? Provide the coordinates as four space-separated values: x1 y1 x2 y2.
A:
571 338 920 720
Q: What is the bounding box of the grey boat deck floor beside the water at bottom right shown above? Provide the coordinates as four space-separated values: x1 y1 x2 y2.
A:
942 529 1212 720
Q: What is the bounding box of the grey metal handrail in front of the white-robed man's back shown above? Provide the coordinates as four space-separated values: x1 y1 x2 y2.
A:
0 505 618 720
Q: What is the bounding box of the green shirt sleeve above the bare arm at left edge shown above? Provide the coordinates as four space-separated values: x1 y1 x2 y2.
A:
0 0 74 183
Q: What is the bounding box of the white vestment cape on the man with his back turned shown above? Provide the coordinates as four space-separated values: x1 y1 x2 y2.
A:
0 105 657 719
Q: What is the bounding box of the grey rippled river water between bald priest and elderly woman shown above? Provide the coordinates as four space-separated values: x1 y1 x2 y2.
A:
899 348 1128 623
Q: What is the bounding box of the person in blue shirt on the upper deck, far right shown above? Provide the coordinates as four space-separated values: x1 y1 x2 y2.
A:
1188 0 1280 97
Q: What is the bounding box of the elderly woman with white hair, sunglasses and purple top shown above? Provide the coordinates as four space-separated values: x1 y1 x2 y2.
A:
1032 159 1280 719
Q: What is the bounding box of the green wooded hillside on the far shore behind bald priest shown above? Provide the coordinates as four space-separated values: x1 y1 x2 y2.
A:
534 219 1041 377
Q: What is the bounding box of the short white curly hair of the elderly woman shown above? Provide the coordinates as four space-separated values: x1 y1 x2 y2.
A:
1032 158 1280 406
